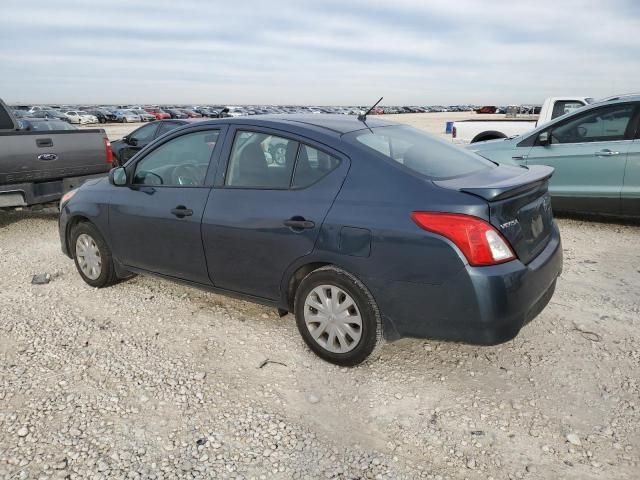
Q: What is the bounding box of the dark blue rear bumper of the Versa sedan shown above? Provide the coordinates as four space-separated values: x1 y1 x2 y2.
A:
373 225 562 345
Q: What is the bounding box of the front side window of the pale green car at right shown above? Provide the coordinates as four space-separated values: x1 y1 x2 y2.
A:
551 104 634 144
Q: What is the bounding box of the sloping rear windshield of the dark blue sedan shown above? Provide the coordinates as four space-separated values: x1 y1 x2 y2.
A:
354 126 495 180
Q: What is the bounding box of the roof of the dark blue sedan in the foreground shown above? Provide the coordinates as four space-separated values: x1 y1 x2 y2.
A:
200 113 399 135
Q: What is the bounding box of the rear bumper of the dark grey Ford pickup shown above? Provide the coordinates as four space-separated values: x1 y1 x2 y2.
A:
0 172 107 207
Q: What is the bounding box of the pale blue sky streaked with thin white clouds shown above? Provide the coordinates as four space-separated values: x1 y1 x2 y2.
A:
0 0 640 105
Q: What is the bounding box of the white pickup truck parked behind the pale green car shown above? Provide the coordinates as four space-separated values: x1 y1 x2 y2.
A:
451 97 593 143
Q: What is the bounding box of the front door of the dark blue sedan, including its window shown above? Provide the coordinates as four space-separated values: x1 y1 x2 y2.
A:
109 127 224 284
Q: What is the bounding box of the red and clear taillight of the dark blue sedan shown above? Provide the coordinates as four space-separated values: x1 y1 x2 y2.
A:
411 212 516 267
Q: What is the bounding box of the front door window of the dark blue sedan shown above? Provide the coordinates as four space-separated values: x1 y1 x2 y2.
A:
133 130 220 186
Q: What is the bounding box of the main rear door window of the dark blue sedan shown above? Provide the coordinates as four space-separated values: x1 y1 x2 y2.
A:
225 131 298 189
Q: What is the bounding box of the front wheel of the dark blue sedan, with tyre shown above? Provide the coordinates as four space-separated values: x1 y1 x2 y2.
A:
69 222 118 288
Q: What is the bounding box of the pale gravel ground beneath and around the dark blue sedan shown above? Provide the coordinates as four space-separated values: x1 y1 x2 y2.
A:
0 117 640 480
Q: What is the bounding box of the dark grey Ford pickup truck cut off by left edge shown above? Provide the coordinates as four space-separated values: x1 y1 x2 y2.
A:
0 99 113 208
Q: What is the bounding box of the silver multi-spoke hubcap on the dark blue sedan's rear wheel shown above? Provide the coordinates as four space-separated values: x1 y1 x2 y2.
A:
304 285 362 353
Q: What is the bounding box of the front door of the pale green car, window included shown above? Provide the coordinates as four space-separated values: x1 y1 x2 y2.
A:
526 103 636 215
